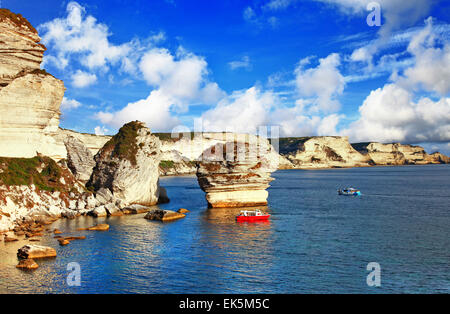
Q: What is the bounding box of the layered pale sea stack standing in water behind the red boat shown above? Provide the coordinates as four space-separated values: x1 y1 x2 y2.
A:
197 137 278 208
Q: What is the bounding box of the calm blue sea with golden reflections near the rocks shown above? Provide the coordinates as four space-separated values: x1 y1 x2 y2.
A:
0 165 450 293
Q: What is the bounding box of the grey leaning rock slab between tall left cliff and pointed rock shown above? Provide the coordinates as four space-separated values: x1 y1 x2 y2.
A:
64 136 95 182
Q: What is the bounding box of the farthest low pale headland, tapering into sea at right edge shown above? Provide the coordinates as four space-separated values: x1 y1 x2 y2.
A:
353 143 450 166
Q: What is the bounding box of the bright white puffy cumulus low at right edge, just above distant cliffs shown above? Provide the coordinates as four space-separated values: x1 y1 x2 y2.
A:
342 84 450 143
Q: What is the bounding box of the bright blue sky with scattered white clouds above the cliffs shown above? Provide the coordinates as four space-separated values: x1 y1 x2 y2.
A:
1 0 450 154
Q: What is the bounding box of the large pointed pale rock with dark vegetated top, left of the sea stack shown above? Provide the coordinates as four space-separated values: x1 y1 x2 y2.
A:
87 121 166 206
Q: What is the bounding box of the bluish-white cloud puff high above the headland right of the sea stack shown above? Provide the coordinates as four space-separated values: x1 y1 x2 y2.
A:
295 53 345 112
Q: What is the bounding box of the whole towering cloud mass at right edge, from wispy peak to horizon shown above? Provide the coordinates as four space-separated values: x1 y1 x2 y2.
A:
342 19 450 143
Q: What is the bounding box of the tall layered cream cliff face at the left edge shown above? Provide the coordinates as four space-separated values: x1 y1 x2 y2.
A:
0 9 65 157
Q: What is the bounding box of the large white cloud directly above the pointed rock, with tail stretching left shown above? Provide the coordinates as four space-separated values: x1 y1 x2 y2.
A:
96 48 224 131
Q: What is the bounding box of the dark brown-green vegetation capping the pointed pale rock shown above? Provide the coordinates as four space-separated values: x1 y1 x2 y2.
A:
100 121 144 166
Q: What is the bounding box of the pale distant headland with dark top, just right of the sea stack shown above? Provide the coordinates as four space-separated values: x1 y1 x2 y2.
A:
280 136 374 169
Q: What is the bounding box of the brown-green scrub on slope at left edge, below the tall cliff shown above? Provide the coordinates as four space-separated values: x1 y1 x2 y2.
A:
0 156 70 192
